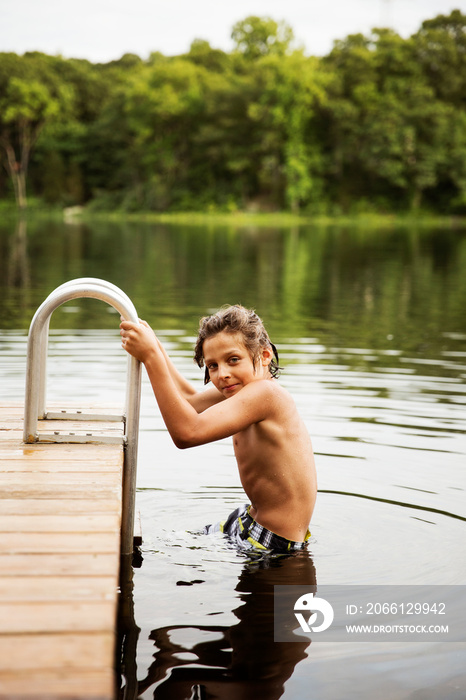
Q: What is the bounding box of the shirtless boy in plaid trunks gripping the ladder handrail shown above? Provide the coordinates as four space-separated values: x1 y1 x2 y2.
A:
120 306 317 552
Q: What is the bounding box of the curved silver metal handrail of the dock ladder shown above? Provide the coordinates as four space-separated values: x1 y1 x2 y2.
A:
23 278 141 554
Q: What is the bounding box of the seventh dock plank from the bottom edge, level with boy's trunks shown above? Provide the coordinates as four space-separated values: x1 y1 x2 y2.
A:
0 512 120 533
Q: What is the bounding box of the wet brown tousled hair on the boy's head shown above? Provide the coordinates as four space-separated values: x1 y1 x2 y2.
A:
194 304 281 384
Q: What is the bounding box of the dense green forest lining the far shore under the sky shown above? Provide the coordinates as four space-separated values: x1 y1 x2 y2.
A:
0 10 466 215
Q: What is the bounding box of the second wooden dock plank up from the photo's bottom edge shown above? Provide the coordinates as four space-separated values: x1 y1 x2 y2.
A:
0 632 114 668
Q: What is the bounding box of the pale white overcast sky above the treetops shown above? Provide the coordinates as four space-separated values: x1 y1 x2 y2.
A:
0 0 466 63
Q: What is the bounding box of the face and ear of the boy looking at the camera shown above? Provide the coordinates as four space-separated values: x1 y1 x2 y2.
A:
203 331 272 398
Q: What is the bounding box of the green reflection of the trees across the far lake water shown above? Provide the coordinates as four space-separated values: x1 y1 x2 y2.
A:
0 221 466 348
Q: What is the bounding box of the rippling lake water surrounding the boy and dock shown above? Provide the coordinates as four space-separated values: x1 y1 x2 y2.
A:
0 221 466 700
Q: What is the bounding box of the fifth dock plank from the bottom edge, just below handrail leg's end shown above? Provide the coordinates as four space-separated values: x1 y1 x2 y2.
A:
0 552 116 577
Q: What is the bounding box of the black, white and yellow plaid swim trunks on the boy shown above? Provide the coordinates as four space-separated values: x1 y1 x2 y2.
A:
204 504 311 554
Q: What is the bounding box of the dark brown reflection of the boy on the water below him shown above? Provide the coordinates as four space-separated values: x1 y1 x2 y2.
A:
129 551 316 700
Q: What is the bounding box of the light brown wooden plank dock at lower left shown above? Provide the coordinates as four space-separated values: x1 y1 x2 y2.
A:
0 405 124 700
